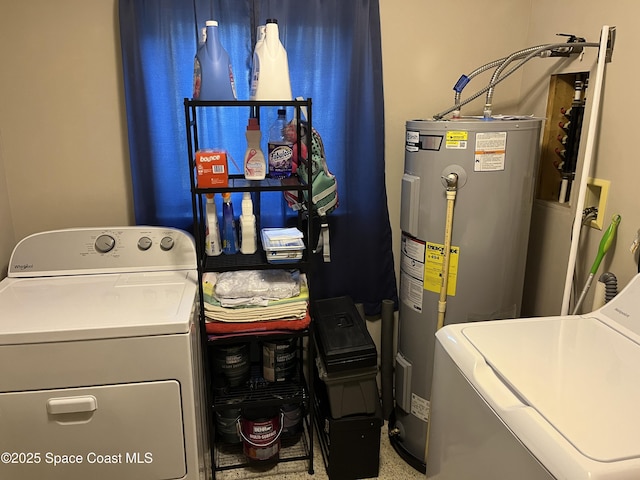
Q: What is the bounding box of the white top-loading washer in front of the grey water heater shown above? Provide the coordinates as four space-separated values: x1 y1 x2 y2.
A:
427 275 640 480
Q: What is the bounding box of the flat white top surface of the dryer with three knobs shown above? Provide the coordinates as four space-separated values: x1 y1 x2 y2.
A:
0 270 197 345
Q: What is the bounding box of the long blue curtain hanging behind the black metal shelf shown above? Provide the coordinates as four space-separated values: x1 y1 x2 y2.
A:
119 0 397 314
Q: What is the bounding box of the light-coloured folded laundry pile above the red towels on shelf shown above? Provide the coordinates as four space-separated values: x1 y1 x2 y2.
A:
202 270 309 324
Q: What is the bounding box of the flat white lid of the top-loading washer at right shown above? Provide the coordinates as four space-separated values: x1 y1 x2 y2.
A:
462 317 640 464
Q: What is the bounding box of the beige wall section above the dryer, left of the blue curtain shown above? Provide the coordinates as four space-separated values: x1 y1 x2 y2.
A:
0 0 133 278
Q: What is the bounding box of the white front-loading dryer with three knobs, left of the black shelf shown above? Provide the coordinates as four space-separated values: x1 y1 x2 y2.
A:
0 227 210 480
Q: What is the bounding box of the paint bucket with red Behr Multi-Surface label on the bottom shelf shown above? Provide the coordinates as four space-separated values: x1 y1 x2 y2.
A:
239 407 284 462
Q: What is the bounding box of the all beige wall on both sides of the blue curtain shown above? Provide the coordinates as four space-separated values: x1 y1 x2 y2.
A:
0 0 640 314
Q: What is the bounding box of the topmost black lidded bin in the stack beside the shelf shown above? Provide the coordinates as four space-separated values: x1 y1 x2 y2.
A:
312 296 378 374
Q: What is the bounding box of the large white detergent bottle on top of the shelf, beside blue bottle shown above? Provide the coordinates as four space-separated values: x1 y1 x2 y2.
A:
250 18 292 100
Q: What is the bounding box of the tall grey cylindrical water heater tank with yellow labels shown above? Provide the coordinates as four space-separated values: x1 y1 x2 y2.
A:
392 118 542 469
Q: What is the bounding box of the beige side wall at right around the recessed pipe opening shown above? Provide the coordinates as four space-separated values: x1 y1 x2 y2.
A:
524 4 640 315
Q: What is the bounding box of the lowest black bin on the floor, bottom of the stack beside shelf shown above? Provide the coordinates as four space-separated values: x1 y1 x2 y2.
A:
314 364 384 480
